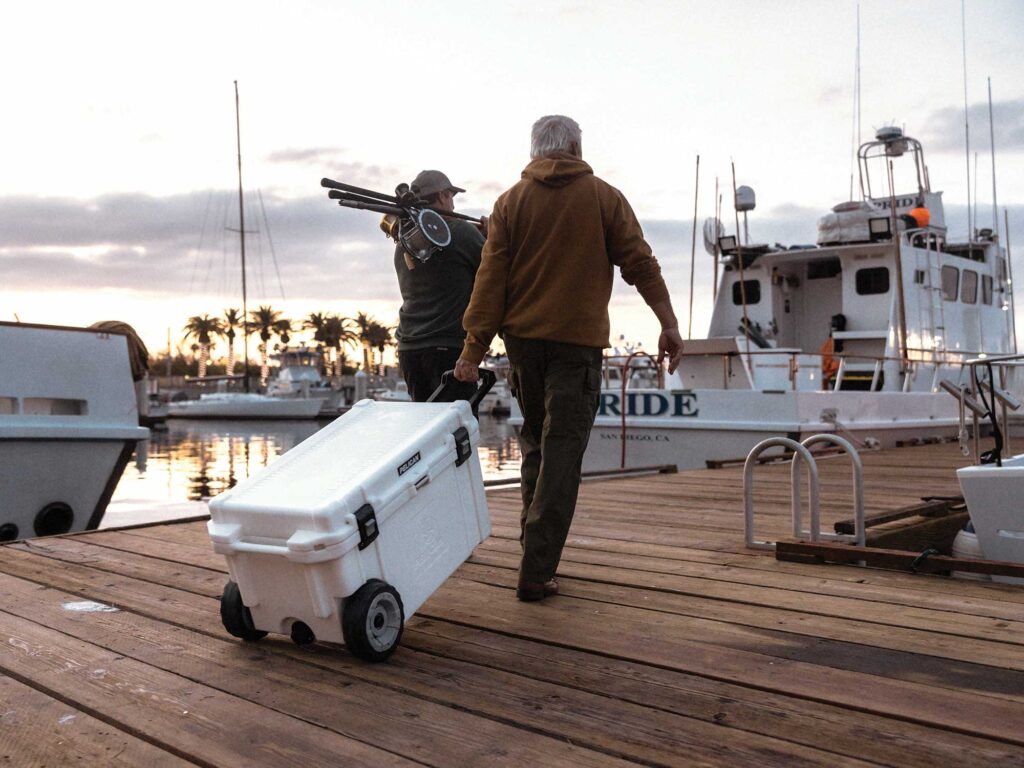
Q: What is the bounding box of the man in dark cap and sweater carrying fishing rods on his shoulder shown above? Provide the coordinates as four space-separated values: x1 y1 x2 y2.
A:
394 171 483 402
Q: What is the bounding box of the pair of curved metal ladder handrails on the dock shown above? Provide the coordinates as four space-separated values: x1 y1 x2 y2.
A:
743 433 865 550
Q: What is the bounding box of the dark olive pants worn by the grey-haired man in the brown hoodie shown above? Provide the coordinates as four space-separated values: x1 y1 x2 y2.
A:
505 335 601 584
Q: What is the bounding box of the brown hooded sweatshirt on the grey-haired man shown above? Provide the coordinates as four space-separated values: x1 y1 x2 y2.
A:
462 153 669 364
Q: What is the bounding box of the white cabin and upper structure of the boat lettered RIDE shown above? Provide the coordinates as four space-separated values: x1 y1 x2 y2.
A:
682 128 1012 391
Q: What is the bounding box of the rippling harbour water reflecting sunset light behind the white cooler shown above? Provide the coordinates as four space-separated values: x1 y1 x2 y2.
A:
112 417 519 508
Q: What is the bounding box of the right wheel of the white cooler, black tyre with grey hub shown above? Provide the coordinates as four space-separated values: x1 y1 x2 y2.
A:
341 579 406 662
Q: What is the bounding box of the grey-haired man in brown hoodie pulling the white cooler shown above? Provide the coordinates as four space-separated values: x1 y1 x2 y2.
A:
455 115 683 601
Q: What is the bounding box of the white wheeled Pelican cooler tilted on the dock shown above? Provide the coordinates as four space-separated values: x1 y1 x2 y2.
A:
209 386 490 662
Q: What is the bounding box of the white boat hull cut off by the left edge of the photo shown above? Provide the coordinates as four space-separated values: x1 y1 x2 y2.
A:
0 323 150 541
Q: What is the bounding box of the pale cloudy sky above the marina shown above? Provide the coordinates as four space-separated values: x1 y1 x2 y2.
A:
0 0 1024 358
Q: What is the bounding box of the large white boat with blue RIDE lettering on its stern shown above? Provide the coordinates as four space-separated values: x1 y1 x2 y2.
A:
512 128 1013 471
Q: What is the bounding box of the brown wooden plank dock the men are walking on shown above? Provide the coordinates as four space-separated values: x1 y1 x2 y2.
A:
0 444 1024 768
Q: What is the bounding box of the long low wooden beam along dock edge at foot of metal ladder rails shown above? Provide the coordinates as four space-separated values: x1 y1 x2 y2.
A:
775 542 1024 579
